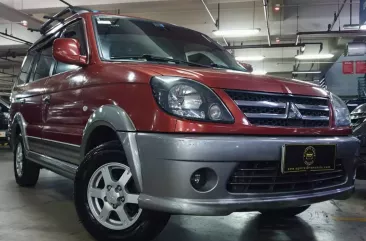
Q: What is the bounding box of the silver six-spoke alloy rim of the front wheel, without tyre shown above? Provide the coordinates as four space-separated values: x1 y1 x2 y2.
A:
87 162 142 230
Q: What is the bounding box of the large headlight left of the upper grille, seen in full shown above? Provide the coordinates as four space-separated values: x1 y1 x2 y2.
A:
151 76 234 123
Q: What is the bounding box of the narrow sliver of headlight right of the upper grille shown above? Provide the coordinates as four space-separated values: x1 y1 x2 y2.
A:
330 93 351 126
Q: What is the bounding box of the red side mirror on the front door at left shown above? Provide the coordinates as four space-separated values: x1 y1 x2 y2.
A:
52 38 87 66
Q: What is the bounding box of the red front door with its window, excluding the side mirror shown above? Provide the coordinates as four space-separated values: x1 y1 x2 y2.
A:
42 20 86 164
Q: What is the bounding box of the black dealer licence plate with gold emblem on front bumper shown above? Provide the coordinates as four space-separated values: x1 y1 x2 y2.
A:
281 144 337 173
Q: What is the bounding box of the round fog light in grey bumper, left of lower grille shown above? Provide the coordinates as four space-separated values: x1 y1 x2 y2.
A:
190 168 218 192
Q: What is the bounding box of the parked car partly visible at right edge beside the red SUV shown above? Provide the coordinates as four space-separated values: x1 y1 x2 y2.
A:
351 104 366 180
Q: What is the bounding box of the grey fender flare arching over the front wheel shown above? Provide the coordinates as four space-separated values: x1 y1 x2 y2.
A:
80 105 142 192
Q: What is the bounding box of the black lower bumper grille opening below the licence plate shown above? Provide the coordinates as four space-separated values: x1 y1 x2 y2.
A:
227 159 347 193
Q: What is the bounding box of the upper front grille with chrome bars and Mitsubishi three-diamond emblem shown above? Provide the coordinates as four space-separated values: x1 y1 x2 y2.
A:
226 90 329 127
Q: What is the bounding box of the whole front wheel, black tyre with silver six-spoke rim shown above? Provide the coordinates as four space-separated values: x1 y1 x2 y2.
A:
74 141 170 241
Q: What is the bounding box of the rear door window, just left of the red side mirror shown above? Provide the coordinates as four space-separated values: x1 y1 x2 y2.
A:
33 45 54 81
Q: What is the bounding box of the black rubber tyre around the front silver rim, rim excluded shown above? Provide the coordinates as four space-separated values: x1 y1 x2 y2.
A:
74 141 169 241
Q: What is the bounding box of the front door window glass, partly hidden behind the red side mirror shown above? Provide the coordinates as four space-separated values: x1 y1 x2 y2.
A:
53 21 87 74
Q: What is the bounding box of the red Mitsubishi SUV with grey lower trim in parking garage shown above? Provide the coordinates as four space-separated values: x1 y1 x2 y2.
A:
10 9 359 240
